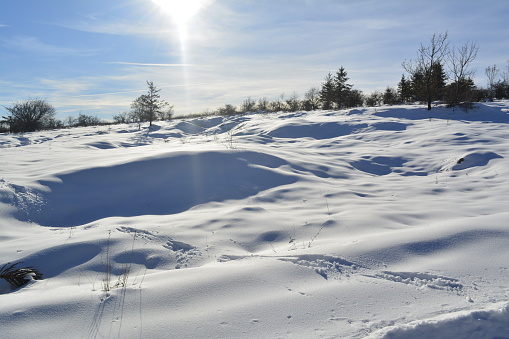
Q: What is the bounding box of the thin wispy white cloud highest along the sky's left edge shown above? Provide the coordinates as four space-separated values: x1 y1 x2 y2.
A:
0 36 96 56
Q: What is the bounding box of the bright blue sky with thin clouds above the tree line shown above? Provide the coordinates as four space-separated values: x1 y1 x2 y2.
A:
0 0 509 119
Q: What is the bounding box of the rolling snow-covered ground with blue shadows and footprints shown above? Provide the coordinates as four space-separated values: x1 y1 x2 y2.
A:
0 101 509 339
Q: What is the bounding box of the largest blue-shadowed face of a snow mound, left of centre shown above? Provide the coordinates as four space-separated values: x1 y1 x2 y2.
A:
13 151 296 227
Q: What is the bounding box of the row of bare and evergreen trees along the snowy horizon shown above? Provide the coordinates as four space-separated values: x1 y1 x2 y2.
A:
0 32 509 132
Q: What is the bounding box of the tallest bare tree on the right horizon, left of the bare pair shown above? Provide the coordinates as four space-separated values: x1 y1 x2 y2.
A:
403 32 449 110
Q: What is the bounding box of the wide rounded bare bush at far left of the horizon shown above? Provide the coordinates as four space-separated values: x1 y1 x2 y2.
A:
4 99 56 132
